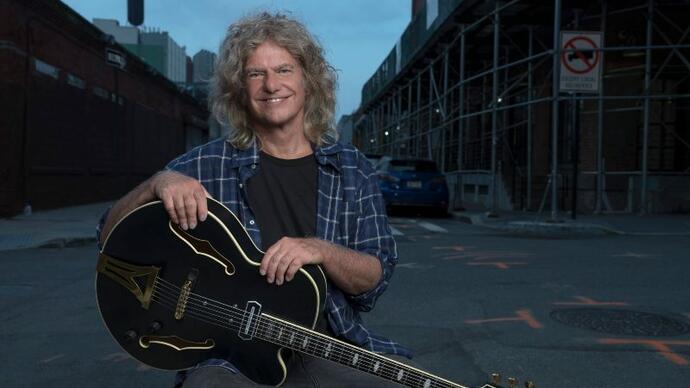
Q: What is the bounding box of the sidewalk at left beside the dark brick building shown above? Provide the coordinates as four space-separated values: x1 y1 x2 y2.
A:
0 202 111 251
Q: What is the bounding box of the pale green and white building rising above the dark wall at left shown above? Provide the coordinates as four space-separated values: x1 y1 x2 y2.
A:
93 19 187 83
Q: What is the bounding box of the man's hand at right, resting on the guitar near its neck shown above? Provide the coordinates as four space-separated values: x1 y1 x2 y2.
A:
259 237 333 285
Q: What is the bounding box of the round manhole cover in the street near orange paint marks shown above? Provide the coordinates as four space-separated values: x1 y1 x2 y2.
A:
550 308 690 337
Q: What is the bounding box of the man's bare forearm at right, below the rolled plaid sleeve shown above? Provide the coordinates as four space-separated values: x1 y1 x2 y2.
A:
323 243 382 295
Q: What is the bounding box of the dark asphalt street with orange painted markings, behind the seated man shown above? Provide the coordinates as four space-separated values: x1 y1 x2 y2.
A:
0 216 690 388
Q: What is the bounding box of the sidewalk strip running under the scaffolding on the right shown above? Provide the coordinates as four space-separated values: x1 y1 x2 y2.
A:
453 209 690 238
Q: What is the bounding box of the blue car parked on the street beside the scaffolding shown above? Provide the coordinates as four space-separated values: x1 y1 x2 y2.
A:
378 157 448 215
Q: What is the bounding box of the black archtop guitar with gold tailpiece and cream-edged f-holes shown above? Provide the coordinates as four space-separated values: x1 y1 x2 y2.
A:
96 199 528 388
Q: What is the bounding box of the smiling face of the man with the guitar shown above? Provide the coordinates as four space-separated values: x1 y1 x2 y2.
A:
244 41 306 131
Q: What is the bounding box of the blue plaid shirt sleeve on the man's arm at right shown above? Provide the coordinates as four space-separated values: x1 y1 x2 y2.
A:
348 165 398 311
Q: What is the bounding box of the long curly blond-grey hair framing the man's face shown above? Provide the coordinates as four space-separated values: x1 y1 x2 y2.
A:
209 12 338 149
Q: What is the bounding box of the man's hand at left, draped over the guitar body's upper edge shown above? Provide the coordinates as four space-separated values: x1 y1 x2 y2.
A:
151 171 208 230
